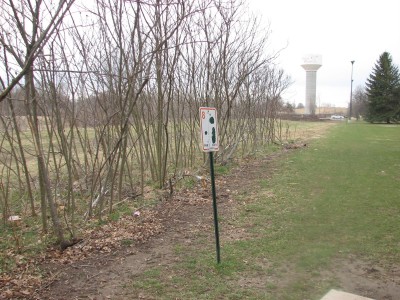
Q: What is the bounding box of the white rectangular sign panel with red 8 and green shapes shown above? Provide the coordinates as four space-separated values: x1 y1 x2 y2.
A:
200 107 219 152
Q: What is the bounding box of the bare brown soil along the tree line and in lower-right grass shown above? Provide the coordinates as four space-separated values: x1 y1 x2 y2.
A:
23 149 400 300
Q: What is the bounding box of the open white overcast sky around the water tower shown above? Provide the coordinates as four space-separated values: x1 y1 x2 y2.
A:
248 0 400 107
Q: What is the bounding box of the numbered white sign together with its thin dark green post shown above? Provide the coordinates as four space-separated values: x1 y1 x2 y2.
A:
200 107 221 264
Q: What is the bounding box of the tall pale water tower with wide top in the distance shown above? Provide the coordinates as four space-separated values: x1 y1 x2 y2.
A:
301 54 322 115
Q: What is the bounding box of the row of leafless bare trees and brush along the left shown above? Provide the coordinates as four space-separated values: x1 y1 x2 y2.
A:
0 0 291 248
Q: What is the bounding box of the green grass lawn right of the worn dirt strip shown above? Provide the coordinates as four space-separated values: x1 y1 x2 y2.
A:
126 123 400 299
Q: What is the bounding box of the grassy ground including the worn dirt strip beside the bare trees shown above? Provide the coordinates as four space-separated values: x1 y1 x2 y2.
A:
28 123 400 299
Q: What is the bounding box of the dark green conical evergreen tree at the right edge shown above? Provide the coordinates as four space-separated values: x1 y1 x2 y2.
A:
366 52 400 123
